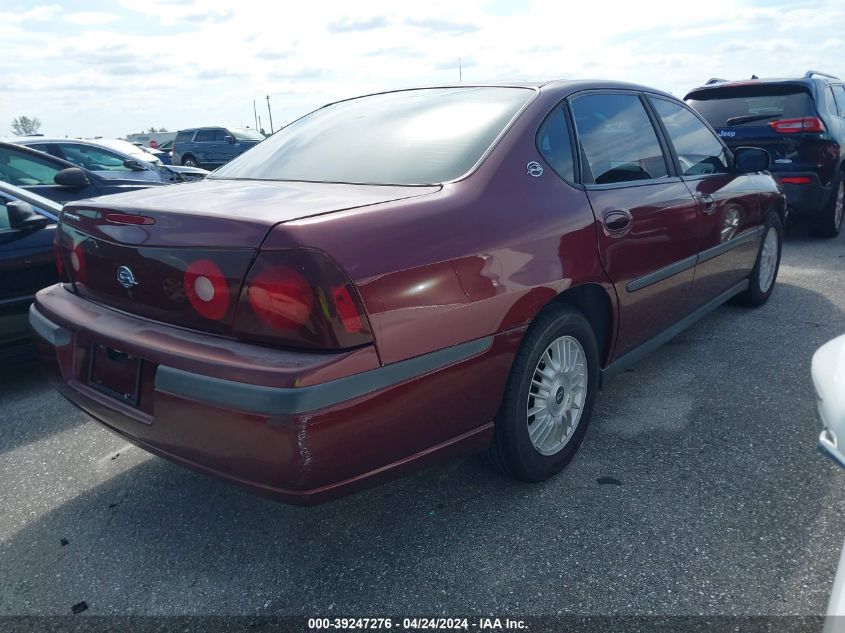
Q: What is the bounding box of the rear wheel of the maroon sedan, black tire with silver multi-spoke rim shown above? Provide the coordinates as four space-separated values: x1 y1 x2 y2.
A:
486 306 599 482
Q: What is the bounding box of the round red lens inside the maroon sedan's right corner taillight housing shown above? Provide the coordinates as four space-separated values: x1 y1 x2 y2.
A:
246 266 314 330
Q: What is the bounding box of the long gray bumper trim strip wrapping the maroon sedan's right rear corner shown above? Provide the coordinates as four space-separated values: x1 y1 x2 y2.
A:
155 336 493 415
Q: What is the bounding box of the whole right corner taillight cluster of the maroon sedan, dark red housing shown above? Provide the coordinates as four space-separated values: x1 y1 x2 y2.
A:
234 250 373 349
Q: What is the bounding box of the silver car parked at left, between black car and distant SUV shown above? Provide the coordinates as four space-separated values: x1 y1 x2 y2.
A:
12 136 208 183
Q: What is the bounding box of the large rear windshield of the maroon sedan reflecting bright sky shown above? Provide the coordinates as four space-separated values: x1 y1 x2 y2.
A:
214 87 534 185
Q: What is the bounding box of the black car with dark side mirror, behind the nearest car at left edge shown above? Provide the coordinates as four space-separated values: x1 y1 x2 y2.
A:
0 142 164 202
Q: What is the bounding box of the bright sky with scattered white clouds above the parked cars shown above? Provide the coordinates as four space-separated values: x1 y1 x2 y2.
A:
0 0 845 137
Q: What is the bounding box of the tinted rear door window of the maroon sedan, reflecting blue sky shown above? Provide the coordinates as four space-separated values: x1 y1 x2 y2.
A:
572 94 669 185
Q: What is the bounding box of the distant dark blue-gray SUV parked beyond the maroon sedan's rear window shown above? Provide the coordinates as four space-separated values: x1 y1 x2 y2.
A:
172 127 264 169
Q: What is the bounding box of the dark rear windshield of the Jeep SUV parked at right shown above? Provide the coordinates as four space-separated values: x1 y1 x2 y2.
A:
687 85 815 127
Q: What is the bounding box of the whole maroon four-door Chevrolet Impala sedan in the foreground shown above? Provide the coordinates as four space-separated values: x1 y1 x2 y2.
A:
31 81 786 503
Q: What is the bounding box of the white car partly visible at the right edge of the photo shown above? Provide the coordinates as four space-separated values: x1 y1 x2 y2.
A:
812 335 845 633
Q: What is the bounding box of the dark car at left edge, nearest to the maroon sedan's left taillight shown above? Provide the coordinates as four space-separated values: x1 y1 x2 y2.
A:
0 182 62 359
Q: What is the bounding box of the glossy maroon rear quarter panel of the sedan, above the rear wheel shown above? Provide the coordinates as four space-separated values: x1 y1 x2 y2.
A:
260 89 609 364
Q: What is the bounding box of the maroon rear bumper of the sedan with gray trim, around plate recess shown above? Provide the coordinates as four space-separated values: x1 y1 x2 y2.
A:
31 285 522 504
